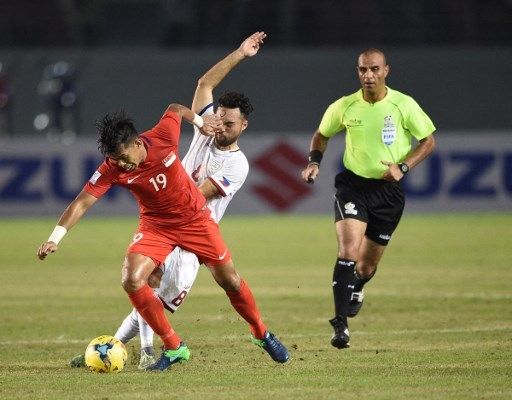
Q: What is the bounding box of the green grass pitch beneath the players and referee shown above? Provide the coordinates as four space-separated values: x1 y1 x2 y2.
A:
0 214 512 400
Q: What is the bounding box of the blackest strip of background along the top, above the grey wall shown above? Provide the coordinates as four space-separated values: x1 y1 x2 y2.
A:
0 0 512 48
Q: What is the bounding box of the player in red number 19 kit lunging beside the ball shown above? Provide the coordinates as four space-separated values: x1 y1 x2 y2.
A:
37 104 288 370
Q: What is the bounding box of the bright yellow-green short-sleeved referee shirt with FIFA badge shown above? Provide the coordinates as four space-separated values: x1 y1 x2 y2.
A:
319 87 435 179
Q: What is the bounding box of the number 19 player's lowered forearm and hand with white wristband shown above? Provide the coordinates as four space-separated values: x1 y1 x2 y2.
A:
37 190 98 260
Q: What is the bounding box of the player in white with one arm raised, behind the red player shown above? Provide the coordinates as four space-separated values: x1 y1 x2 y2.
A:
71 32 266 369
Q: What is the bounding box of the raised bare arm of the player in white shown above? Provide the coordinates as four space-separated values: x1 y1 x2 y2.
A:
192 32 267 113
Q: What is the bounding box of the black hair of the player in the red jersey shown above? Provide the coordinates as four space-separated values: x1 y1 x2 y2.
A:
96 110 139 156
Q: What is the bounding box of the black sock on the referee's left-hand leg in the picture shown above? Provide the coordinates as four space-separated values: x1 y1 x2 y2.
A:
332 258 356 325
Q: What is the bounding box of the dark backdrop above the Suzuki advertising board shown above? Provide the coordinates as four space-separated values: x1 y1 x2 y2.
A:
0 0 512 135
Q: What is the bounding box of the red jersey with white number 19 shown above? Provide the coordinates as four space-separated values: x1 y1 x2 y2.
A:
84 111 206 226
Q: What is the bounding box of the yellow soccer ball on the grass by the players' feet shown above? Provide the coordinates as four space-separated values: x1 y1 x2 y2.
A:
85 335 128 372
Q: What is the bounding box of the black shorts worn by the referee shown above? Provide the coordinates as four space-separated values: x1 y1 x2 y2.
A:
334 170 405 246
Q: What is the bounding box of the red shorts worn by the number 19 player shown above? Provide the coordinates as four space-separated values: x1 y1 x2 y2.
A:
126 216 231 266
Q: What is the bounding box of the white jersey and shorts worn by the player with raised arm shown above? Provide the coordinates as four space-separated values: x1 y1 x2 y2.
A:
156 104 249 312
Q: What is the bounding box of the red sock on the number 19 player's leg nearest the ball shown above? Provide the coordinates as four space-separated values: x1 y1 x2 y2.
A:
128 285 181 349
